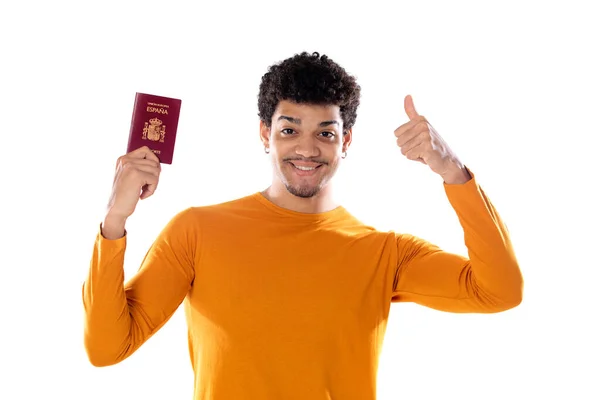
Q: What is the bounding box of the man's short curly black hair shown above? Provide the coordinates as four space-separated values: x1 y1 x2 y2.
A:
258 52 360 133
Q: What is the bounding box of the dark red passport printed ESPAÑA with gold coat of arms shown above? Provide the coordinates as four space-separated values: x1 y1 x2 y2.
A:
127 93 181 164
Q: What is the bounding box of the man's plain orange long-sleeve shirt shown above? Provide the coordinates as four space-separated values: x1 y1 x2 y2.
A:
83 173 523 400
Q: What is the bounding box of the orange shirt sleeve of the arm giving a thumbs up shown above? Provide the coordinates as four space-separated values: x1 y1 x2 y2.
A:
392 171 523 313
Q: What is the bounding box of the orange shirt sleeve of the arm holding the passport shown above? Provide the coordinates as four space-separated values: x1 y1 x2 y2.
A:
82 209 197 366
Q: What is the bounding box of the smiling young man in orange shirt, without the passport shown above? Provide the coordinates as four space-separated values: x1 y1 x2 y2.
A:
83 53 523 400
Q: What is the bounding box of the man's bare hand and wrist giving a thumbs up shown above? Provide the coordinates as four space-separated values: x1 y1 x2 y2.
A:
394 95 471 184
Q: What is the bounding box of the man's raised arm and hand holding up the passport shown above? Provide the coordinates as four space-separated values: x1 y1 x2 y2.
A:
82 148 196 366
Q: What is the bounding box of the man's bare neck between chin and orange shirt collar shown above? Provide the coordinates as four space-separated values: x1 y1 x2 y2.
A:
261 182 339 214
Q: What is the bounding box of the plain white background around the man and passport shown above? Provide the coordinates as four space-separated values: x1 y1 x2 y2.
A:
0 0 600 400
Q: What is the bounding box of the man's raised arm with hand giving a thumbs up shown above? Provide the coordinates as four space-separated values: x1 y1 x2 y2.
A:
392 96 523 312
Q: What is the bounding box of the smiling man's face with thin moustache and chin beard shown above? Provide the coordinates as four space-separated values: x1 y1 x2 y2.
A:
260 100 352 198
